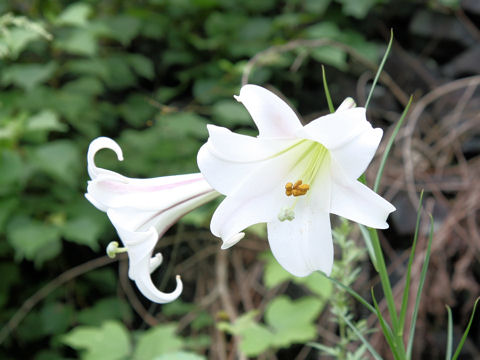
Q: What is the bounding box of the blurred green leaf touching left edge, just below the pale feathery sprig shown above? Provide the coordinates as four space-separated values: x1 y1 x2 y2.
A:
1 61 57 91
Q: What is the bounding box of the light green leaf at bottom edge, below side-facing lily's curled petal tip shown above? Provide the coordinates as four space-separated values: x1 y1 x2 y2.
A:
133 324 183 360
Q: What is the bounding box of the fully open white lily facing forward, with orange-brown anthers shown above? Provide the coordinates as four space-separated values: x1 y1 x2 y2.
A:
197 85 395 276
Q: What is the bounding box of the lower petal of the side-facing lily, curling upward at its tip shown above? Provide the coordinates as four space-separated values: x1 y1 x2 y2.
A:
109 222 183 304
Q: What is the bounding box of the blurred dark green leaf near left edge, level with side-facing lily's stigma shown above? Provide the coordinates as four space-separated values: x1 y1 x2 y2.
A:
7 216 62 266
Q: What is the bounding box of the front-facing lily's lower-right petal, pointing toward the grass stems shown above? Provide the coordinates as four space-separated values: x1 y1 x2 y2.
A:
330 163 395 229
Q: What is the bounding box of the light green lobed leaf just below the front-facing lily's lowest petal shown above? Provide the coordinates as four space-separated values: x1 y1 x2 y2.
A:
265 296 323 347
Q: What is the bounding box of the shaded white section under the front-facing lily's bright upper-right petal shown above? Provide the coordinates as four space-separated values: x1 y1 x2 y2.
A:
330 128 383 180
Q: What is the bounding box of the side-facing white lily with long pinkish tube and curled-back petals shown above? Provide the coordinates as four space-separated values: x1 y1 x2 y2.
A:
85 137 219 304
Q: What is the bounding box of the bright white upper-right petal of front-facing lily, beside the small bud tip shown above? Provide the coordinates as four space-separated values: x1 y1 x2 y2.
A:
296 107 372 150
